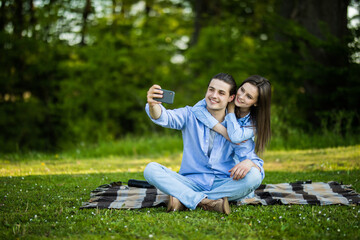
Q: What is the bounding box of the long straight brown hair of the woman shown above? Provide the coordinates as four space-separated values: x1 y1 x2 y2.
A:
235 75 271 154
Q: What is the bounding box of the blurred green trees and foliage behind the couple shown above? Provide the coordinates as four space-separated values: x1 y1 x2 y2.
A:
0 0 360 152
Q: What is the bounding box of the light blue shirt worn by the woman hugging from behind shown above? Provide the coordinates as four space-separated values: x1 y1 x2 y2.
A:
192 99 254 143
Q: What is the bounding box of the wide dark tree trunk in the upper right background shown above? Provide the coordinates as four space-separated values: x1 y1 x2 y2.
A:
280 0 349 110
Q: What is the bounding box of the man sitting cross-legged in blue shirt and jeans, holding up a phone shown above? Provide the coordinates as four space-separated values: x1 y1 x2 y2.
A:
144 73 264 214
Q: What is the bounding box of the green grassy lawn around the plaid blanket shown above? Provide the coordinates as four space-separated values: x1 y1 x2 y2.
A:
0 145 360 239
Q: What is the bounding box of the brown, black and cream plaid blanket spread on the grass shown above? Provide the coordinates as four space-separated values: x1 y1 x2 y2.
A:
81 181 360 209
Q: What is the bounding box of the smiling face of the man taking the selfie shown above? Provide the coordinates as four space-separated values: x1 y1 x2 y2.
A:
205 79 235 111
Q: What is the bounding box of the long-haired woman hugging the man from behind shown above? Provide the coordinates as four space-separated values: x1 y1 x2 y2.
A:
192 75 271 154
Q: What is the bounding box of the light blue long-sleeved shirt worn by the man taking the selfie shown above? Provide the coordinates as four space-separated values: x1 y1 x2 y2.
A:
145 104 265 190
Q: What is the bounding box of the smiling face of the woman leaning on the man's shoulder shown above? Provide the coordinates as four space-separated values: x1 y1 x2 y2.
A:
234 82 259 110
